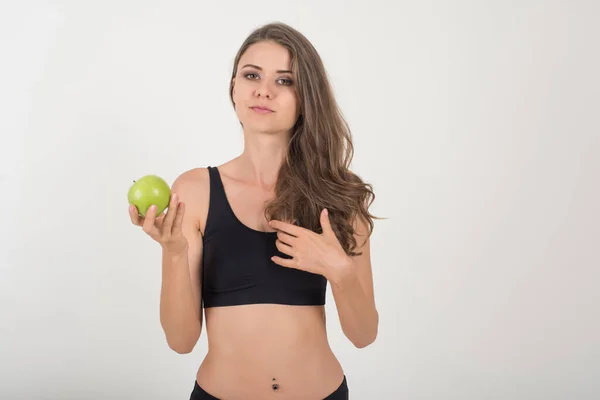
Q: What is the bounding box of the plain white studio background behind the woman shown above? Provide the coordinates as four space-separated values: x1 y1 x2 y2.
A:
0 0 600 400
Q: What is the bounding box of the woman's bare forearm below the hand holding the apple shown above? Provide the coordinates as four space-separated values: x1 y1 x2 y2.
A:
160 250 202 353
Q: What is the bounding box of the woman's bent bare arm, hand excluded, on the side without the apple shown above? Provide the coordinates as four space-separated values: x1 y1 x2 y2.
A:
329 214 379 348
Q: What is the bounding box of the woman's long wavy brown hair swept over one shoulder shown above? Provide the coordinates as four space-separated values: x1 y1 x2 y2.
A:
229 22 377 256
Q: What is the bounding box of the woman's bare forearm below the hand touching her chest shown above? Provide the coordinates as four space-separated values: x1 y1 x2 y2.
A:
329 265 379 348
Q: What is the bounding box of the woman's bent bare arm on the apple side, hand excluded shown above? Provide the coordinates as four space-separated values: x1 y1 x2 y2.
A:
160 173 203 354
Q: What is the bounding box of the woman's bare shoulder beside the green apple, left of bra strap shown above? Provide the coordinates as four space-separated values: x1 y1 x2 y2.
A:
171 168 210 234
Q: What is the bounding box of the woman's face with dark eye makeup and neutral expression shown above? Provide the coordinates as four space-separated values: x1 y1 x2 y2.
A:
232 42 299 133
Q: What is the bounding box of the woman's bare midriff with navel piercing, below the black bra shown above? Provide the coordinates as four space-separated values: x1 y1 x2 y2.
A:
197 304 343 399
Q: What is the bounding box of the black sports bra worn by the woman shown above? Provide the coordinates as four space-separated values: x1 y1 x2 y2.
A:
202 166 327 308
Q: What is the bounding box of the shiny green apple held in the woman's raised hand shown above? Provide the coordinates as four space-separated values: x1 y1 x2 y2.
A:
127 175 171 217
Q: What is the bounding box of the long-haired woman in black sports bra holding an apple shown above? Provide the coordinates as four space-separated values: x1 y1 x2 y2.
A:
130 23 379 400
